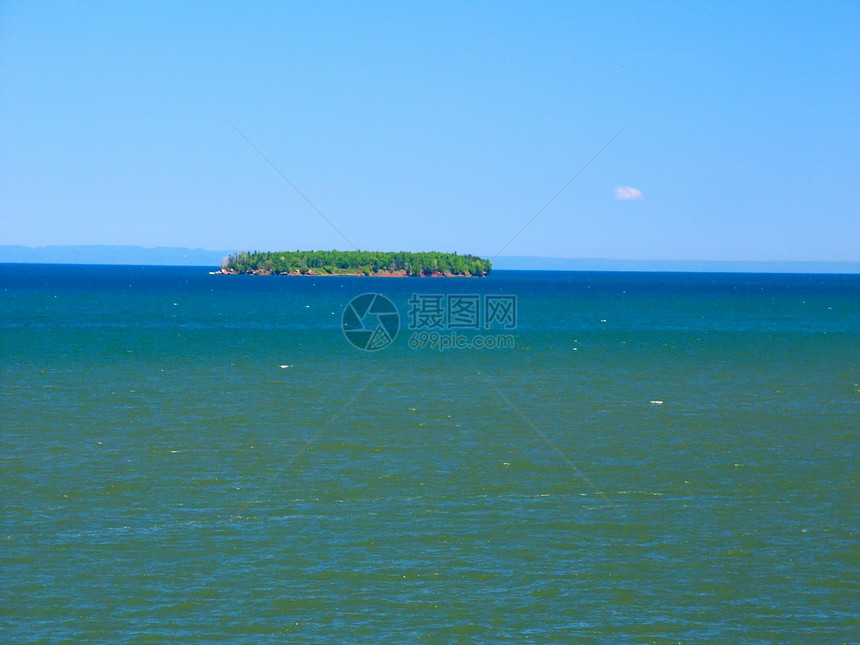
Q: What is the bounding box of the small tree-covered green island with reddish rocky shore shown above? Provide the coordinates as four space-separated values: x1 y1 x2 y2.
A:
215 251 492 277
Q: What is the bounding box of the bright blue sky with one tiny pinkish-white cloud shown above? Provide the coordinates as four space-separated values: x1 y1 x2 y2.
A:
0 0 860 261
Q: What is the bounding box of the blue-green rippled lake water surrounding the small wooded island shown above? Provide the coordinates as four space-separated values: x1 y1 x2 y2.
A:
0 265 860 643
